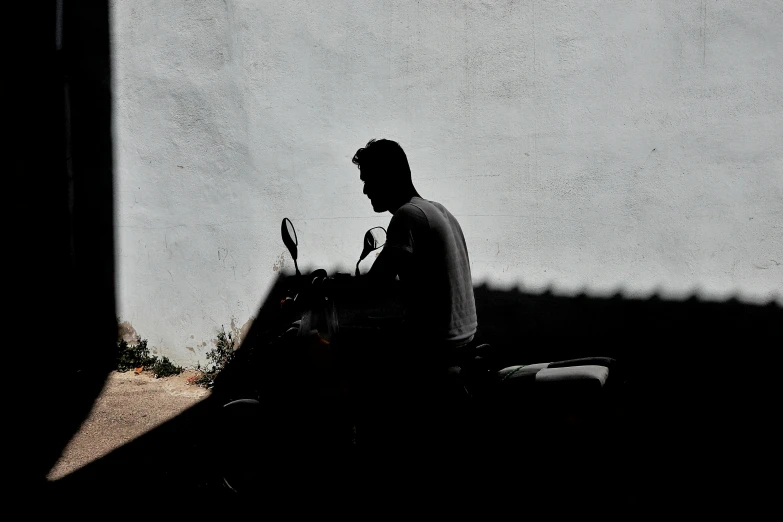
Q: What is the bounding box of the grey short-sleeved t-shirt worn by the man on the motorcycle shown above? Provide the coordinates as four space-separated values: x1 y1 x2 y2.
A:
384 197 478 344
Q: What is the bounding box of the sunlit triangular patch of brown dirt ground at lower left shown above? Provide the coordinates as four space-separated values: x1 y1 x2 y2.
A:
47 371 209 480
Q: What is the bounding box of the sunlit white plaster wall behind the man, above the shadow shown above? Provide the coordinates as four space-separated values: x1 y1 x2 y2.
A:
112 0 783 364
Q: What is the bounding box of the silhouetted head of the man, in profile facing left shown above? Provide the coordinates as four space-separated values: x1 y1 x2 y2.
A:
352 139 418 212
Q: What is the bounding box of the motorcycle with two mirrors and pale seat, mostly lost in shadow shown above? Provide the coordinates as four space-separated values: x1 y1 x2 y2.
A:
216 218 624 506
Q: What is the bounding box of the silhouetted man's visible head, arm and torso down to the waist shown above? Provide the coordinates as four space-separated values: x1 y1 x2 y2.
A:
353 139 477 355
